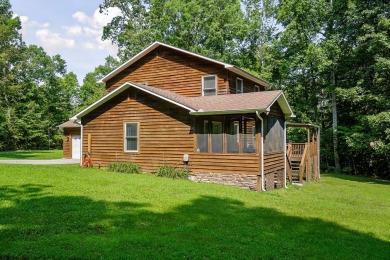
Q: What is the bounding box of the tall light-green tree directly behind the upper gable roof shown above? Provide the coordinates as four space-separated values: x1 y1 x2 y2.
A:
100 0 247 62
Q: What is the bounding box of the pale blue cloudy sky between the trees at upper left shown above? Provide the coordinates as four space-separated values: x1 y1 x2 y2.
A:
10 0 120 83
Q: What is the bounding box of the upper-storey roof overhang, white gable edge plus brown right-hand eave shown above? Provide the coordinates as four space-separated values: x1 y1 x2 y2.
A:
99 42 270 88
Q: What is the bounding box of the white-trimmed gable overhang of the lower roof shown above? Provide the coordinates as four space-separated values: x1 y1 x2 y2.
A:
70 82 195 120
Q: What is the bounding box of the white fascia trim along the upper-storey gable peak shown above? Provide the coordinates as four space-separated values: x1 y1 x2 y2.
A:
99 41 232 83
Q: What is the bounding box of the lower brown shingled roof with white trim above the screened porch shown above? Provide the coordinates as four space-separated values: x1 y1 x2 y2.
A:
71 82 294 120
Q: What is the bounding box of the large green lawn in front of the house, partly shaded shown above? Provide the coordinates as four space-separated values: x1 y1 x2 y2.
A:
0 165 390 259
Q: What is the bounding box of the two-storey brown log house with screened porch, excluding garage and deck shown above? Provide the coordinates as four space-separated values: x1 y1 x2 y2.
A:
71 42 294 191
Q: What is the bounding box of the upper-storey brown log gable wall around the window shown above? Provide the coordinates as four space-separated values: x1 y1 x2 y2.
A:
106 46 228 96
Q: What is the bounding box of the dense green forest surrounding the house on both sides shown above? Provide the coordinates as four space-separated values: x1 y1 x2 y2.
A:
0 0 390 178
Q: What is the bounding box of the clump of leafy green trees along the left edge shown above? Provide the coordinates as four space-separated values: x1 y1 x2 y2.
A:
0 0 79 150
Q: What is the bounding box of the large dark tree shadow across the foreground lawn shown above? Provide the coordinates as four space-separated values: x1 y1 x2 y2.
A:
0 185 390 259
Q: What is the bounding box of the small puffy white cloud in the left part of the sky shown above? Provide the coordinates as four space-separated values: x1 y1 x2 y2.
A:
35 28 76 52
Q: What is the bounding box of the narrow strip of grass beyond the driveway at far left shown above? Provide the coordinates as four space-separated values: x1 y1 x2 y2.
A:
0 150 62 160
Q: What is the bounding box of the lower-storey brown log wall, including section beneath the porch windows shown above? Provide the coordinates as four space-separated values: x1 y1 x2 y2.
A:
82 89 260 174
